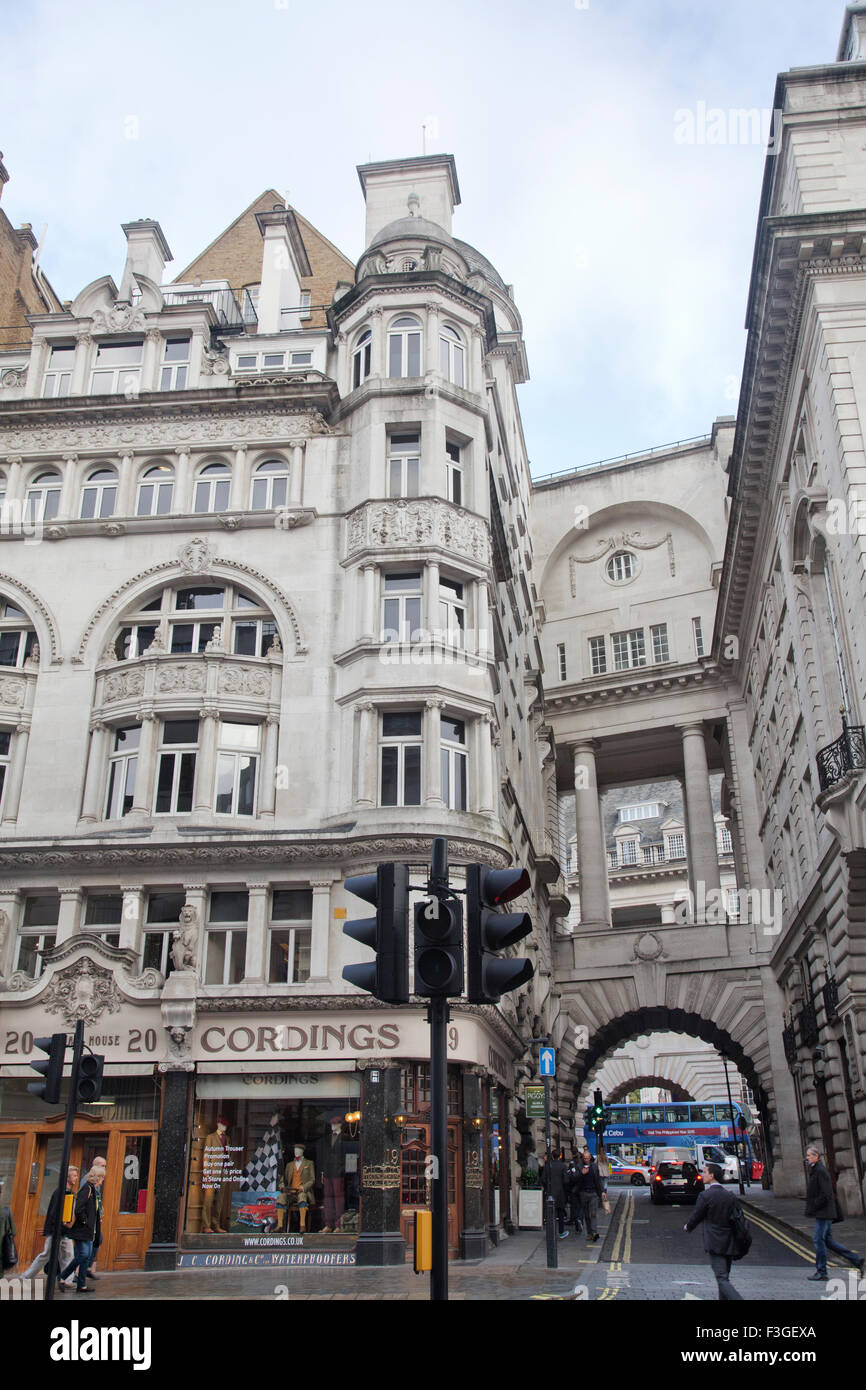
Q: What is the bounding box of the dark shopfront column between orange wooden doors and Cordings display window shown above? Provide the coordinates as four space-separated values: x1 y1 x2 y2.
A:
145 1062 193 1269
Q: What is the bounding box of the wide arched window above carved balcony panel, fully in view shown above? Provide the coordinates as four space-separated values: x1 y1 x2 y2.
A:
114 581 277 662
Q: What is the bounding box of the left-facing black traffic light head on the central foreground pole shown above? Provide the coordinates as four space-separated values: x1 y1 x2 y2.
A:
343 865 409 1004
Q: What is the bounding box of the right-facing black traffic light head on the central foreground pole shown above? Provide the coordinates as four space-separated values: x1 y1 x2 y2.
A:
466 865 535 1004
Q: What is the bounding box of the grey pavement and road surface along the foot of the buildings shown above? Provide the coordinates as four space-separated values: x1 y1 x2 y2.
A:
11 1187 866 1316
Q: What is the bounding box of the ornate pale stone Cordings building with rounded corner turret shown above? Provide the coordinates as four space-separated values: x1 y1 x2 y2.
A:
0 156 567 1268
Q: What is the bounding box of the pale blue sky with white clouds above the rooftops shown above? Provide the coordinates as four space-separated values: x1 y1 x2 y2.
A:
0 0 845 477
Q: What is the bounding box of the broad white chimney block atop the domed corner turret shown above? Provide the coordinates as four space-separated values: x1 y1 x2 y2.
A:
357 154 460 246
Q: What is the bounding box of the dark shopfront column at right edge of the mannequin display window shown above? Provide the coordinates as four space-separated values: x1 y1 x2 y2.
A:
354 1066 406 1266
